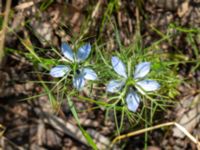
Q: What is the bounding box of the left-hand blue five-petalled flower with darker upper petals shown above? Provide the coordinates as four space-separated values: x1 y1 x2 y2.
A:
50 43 97 91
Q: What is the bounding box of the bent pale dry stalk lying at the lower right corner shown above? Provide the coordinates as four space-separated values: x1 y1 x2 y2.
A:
112 122 200 150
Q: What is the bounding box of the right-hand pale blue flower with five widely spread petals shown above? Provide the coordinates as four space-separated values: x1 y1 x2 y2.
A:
106 56 160 112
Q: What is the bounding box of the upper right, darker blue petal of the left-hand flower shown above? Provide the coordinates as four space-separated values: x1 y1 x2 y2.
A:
77 43 91 62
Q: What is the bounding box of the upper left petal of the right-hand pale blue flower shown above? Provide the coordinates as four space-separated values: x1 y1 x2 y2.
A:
111 56 127 78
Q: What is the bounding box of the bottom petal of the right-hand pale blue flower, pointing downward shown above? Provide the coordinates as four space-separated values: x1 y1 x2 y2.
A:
126 90 140 112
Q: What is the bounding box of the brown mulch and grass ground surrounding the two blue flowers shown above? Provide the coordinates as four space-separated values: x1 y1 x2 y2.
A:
0 0 200 150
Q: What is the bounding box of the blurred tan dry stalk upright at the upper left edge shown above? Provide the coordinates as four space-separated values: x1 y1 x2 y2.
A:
0 0 11 64
